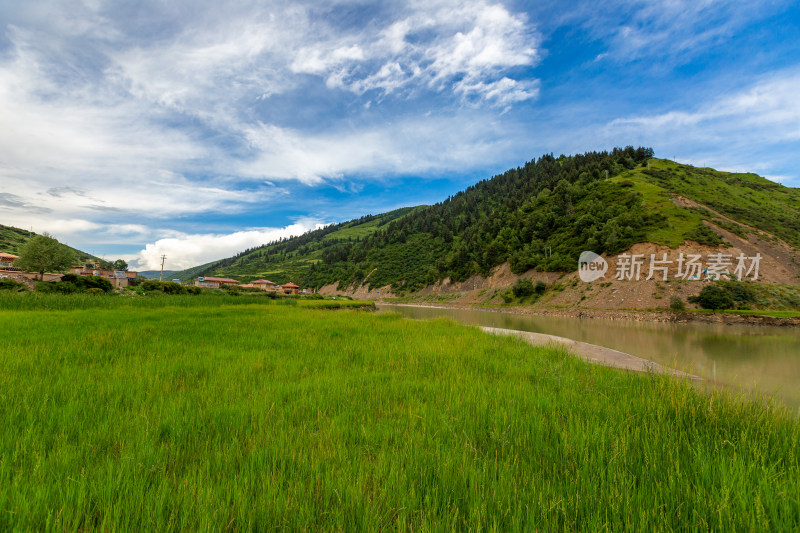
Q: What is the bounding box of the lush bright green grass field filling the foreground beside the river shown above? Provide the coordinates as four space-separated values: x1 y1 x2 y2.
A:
0 297 800 531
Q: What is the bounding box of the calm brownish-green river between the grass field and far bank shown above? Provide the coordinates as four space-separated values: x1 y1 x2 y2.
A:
378 304 800 406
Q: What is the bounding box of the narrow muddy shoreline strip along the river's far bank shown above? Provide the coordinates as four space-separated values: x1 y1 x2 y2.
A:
375 300 800 327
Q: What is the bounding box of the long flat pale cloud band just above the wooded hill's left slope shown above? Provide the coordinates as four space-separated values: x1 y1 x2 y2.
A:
236 111 524 185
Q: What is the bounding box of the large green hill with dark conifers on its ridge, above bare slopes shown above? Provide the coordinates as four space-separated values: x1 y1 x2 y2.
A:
181 147 800 293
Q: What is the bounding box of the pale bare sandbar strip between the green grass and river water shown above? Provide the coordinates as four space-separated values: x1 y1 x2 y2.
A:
481 326 703 381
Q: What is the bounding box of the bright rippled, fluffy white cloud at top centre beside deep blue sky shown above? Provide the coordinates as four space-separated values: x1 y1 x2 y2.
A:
290 1 540 105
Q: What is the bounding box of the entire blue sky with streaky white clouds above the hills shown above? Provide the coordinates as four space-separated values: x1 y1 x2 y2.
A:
0 0 800 270
